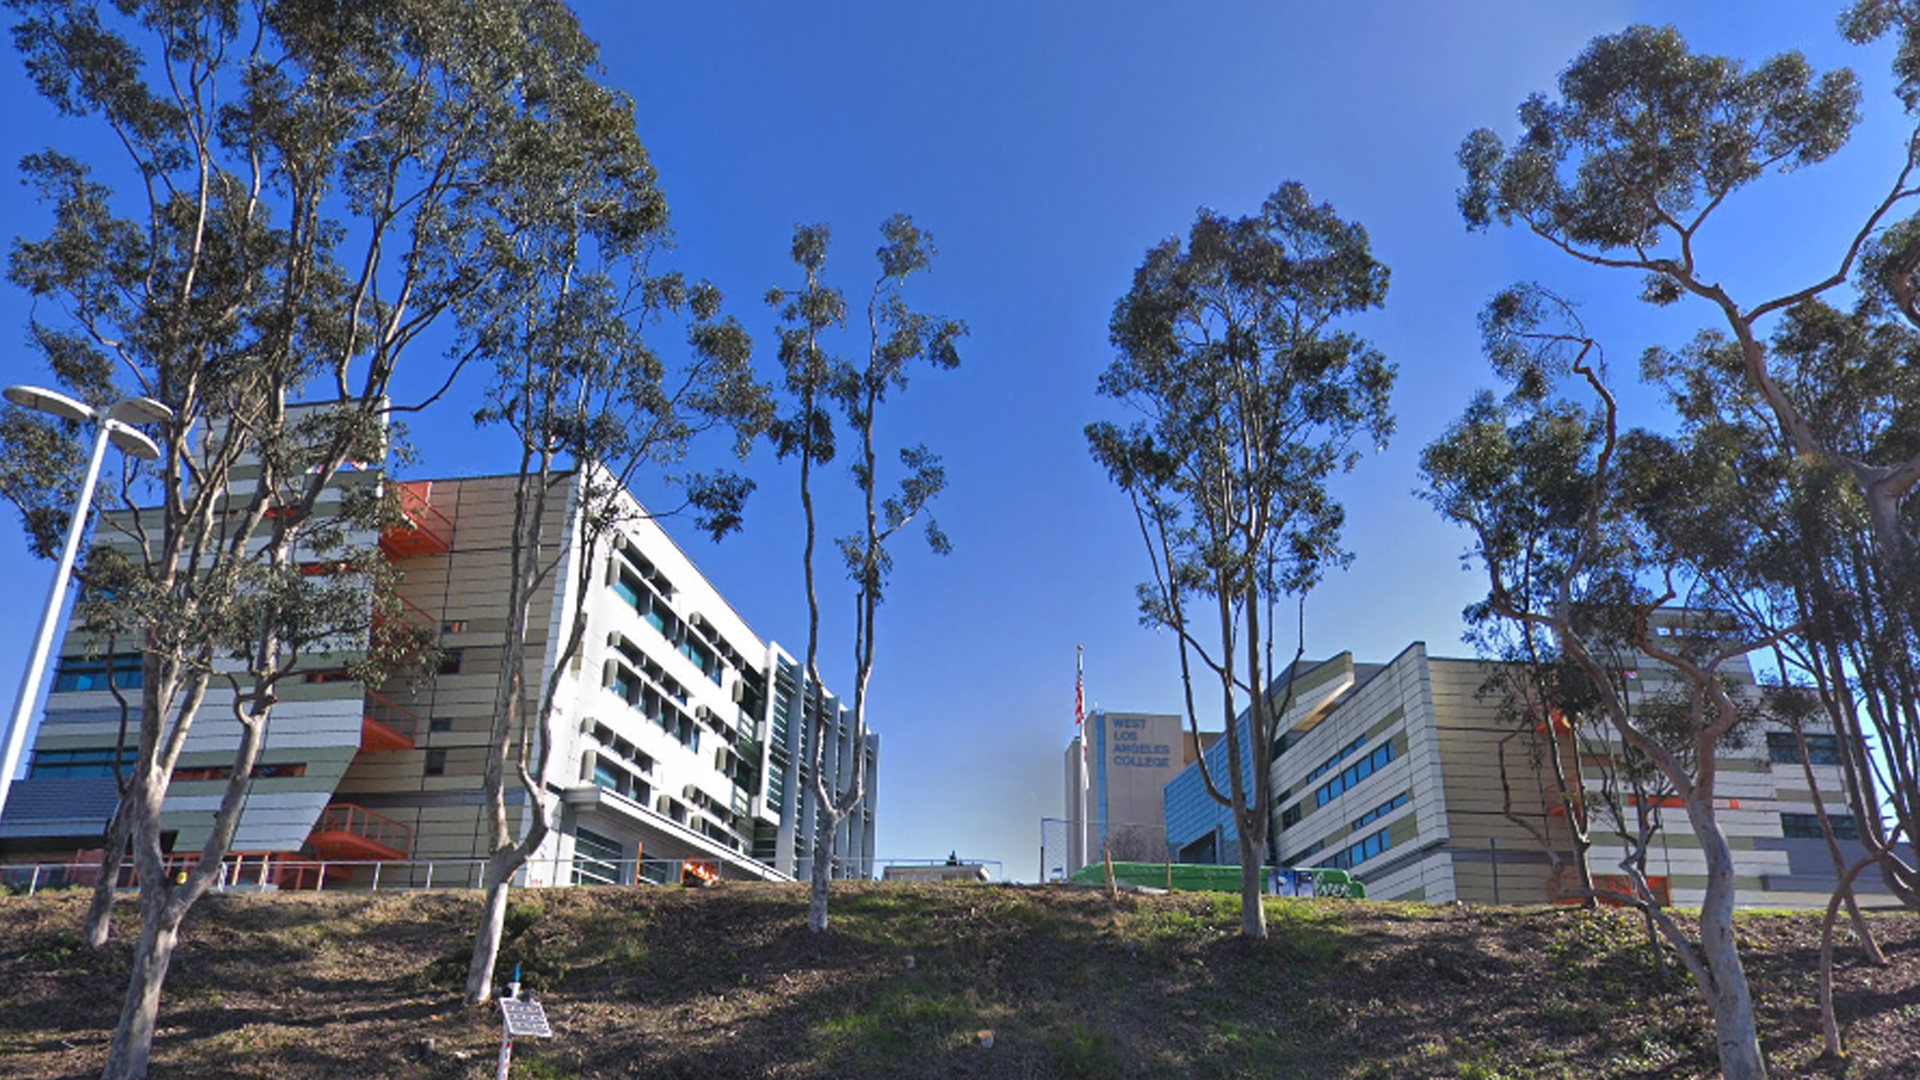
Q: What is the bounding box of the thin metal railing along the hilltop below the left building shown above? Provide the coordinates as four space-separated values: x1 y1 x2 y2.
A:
0 853 1004 896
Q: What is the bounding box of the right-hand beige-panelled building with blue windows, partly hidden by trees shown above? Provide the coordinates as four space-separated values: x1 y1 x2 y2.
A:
1236 642 1882 907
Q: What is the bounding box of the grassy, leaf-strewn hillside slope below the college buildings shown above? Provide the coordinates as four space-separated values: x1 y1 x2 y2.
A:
0 884 1920 1080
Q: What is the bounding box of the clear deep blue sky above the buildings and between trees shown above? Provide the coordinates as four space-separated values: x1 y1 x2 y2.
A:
0 0 1905 878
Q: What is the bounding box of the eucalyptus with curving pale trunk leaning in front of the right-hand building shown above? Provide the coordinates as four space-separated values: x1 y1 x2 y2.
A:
1421 286 1782 1080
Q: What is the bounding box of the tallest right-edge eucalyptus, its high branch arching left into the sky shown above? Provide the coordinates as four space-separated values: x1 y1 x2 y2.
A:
1459 18 1920 905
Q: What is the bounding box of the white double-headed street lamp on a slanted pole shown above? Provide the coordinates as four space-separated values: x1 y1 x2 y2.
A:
0 386 173 815
